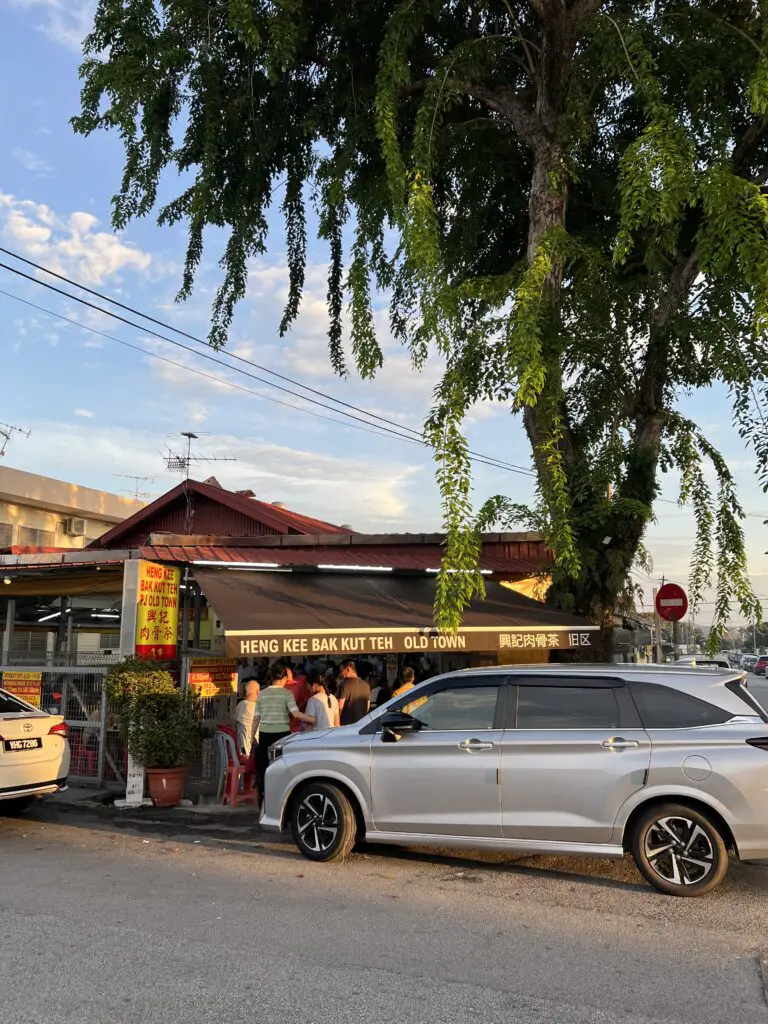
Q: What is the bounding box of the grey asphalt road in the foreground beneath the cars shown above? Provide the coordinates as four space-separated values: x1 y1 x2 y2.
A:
0 805 768 1024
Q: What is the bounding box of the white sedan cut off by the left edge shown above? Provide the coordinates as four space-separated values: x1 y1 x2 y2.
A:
0 690 70 815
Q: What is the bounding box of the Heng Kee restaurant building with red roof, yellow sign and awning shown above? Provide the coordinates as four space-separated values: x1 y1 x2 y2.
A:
0 480 595 787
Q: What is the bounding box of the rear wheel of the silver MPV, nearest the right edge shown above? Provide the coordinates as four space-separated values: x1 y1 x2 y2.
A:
631 804 728 896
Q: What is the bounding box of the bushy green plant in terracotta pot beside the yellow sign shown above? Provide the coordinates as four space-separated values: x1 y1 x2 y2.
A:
106 657 200 807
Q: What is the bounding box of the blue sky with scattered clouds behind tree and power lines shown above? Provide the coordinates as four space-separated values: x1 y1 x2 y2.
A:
0 0 768 623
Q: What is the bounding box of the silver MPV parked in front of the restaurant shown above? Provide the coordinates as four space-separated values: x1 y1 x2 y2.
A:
261 665 768 896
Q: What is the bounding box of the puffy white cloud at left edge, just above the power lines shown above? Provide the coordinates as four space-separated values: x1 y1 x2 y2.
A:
0 191 152 285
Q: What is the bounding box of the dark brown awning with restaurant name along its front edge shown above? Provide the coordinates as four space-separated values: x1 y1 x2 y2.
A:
195 569 596 657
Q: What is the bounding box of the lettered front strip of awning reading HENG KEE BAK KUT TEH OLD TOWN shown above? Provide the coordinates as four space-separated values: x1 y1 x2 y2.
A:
226 627 592 657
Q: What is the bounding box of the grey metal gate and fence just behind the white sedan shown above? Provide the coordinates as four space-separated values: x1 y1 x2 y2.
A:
0 665 126 786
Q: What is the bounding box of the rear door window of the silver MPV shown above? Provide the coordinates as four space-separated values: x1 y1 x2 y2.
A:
517 686 620 729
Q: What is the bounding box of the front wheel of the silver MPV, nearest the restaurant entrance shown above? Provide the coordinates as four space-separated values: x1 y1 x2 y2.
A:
291 782 356 860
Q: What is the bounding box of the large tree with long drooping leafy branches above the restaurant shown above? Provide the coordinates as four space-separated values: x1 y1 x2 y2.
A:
74 0 768 651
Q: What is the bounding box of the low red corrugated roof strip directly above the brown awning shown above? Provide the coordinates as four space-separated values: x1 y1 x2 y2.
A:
139 544 541 575
